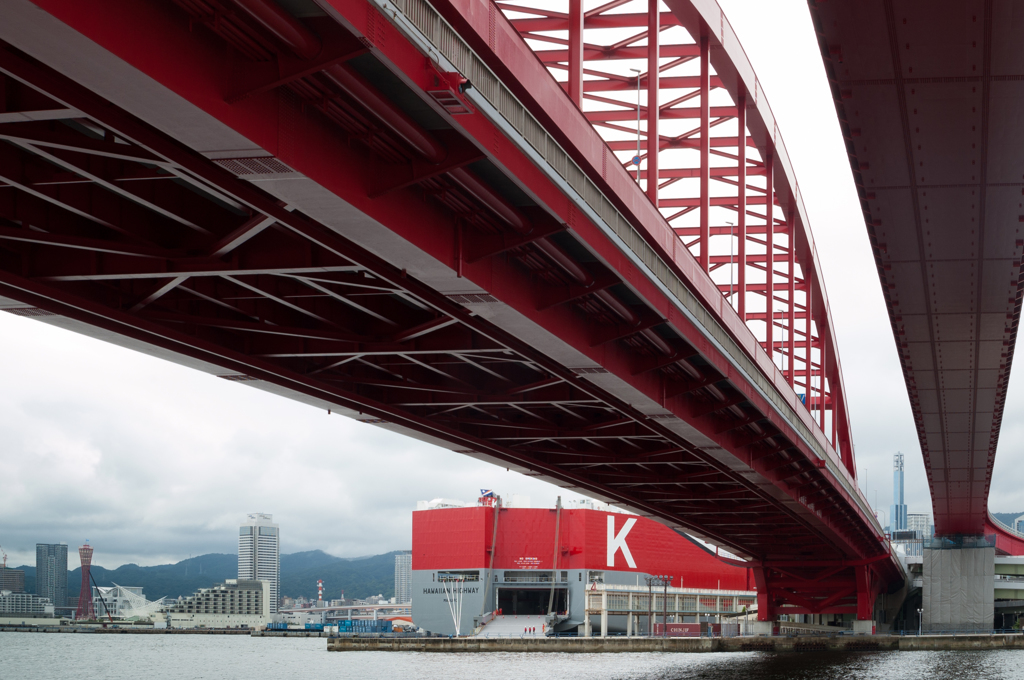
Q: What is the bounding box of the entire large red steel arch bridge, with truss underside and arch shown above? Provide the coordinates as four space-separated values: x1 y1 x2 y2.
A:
0 0 913 620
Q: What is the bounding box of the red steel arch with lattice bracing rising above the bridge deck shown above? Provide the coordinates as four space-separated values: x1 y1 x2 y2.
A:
483 0 856 475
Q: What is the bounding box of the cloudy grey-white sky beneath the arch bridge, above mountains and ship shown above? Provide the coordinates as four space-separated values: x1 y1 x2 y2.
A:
0 314 593 566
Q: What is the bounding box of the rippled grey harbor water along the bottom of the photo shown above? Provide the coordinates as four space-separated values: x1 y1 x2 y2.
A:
6 633 1024 680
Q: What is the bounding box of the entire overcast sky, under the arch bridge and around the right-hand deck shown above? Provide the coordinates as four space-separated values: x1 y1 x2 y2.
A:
0 0 1024 567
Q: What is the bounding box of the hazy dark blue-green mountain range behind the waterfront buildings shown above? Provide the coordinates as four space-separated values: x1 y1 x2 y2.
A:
17 550 396 600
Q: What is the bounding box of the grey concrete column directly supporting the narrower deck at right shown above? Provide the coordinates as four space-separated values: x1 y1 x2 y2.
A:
922 536 995 631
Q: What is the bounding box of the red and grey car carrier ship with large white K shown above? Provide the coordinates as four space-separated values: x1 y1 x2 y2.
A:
412 492 757 635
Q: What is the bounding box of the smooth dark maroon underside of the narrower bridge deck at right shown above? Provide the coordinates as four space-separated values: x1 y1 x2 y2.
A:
810 0 1024 550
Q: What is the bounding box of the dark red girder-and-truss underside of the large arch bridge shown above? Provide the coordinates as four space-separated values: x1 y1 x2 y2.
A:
0 0 901 618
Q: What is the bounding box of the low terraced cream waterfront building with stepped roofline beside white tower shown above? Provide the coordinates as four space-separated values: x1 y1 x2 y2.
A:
167 579 272 628
